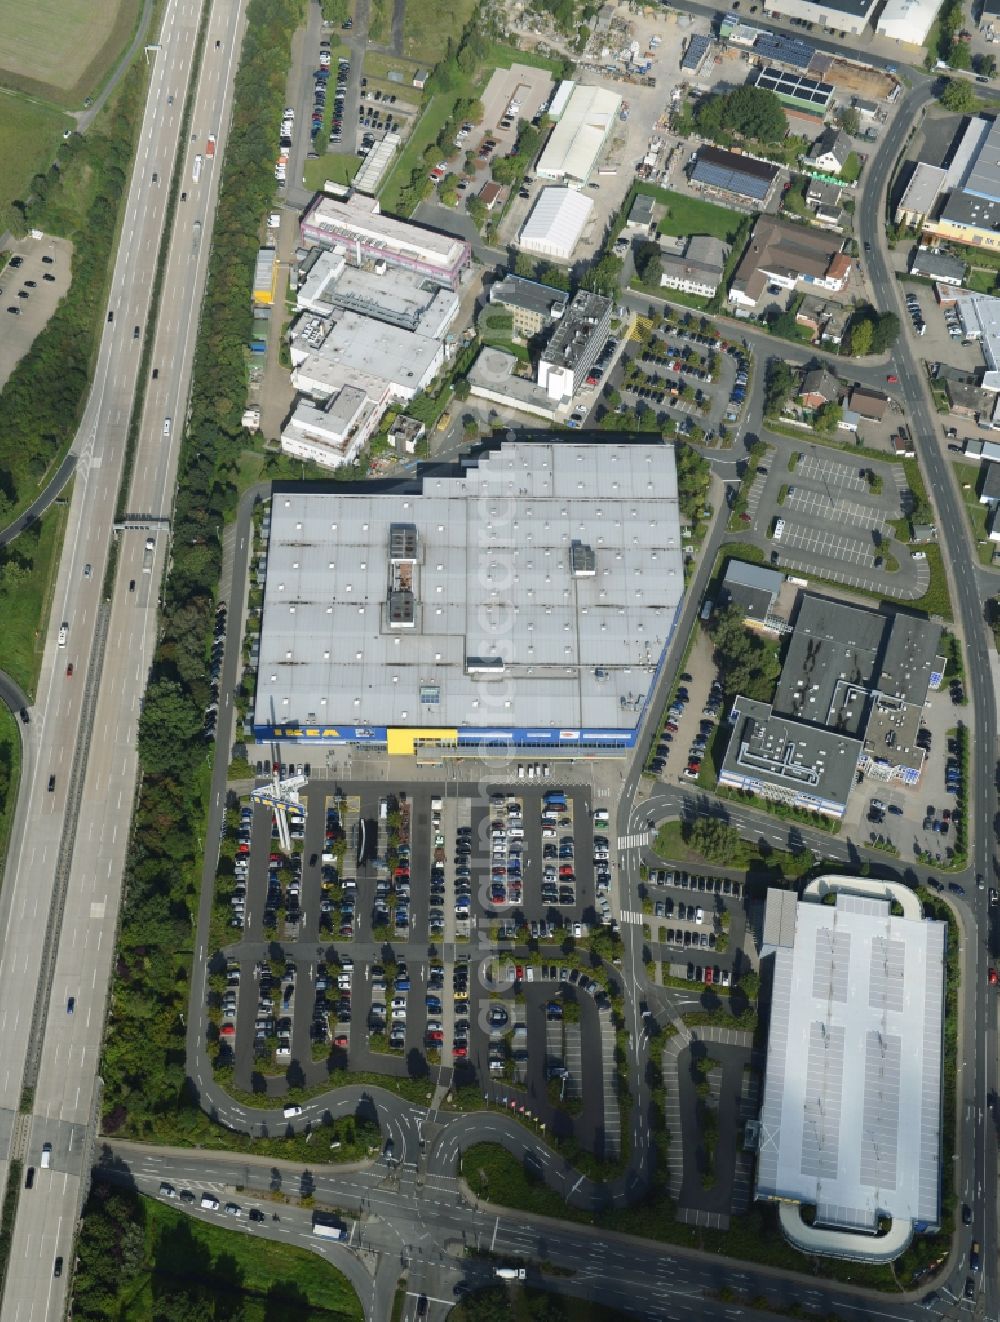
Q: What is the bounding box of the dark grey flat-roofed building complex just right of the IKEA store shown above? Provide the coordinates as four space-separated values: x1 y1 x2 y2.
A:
720 592 944 818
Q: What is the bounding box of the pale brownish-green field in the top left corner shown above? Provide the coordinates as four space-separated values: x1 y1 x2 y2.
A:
0 0 142 106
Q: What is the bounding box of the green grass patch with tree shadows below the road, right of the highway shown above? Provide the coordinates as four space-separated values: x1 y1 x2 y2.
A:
123 1199 364 1322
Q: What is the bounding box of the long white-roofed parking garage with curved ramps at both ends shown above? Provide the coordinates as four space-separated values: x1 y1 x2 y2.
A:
757 878 947 1237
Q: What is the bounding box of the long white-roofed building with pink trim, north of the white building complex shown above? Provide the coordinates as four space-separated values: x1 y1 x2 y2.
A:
300 193 472 290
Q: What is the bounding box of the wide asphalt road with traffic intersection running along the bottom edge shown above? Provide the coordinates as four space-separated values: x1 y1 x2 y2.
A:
97 1136 952 1322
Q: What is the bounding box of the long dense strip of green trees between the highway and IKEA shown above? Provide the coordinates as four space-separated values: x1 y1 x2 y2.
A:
102 0 303 1136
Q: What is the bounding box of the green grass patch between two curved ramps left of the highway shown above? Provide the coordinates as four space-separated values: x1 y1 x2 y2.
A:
0 485 73 698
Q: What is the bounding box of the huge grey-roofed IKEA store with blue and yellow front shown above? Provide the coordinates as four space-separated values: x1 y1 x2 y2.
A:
254 440 684 756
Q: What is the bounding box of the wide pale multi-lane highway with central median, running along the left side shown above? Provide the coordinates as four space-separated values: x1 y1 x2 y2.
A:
0 0 250 1322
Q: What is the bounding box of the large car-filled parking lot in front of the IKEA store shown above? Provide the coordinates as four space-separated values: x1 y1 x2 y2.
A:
209 764 616 1136
